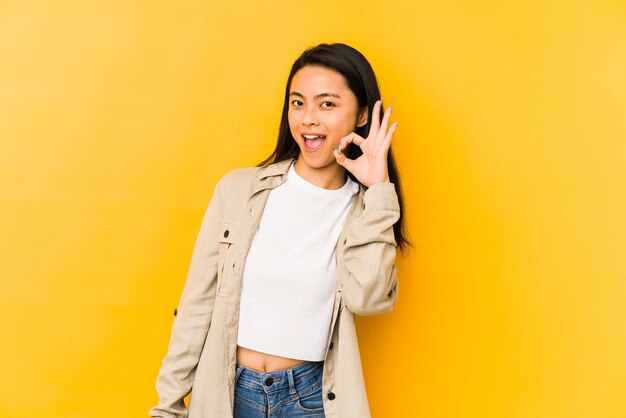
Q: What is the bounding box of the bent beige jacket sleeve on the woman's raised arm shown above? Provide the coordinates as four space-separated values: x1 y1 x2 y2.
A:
341 183 400 315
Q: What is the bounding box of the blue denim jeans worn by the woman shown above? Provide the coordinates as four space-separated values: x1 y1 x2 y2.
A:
234 361 324 418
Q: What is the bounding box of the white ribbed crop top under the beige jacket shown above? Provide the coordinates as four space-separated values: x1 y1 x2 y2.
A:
237 164 359 361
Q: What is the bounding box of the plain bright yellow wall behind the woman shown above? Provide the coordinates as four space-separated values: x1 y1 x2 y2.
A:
0 0 626 418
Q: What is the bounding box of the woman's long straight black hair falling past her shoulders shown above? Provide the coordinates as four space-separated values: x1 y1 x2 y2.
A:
258 43 412 252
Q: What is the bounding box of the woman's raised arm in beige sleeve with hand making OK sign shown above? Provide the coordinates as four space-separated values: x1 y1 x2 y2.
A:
334 100 400 315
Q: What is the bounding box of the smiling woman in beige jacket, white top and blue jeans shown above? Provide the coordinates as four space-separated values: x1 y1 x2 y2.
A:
150 44 410 418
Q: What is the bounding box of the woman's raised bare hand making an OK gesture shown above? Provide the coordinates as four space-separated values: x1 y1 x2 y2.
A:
333 100 398 187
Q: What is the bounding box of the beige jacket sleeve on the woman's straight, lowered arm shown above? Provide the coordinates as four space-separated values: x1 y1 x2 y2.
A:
150 179 222 418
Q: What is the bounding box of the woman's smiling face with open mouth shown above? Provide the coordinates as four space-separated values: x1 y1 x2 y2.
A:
288 65 367 168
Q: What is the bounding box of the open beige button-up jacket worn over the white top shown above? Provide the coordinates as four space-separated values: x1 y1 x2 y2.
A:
150 160 400 418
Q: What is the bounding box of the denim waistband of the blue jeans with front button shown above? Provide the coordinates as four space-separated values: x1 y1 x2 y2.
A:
235 361 324 393
